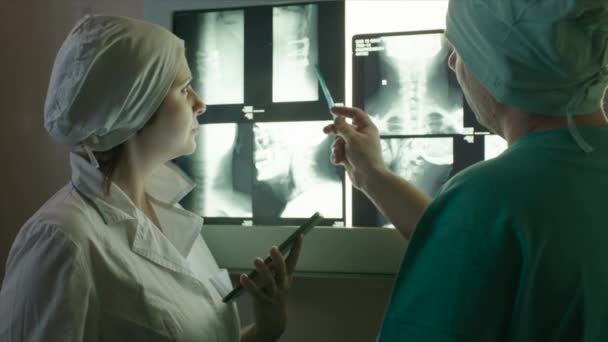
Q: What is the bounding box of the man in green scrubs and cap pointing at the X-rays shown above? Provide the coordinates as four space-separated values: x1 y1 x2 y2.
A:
325 0 608 342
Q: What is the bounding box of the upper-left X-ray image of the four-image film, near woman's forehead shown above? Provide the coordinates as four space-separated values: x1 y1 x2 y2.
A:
191 10 245 105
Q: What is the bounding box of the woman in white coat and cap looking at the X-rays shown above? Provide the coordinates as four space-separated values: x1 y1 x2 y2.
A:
0 16 301 341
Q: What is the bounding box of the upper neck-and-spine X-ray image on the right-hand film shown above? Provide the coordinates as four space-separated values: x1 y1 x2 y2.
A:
364 33 463 135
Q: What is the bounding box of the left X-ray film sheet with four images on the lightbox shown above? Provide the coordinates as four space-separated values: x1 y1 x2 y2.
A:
173 2 347 227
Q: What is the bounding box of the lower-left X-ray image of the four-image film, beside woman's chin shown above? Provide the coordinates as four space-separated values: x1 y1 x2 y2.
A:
189 123 252 218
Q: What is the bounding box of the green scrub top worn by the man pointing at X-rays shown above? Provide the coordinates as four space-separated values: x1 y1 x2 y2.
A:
378 126 608 342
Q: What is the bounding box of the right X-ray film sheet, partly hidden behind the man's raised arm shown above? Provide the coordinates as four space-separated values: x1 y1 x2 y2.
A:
352 30 501 227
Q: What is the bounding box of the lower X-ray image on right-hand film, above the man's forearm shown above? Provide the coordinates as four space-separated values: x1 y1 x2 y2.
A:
380 138 454 197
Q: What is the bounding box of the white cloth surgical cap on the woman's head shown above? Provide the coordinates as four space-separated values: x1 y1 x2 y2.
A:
44 16 184 152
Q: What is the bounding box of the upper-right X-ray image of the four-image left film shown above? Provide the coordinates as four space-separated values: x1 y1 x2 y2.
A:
272 4 319 102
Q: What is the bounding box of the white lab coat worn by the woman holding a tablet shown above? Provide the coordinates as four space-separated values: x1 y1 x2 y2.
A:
0 154 240 342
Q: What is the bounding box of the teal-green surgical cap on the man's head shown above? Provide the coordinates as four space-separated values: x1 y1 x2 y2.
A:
447 0 608 120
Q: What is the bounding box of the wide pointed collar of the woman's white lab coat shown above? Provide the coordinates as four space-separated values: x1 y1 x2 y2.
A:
70 153 203 260
